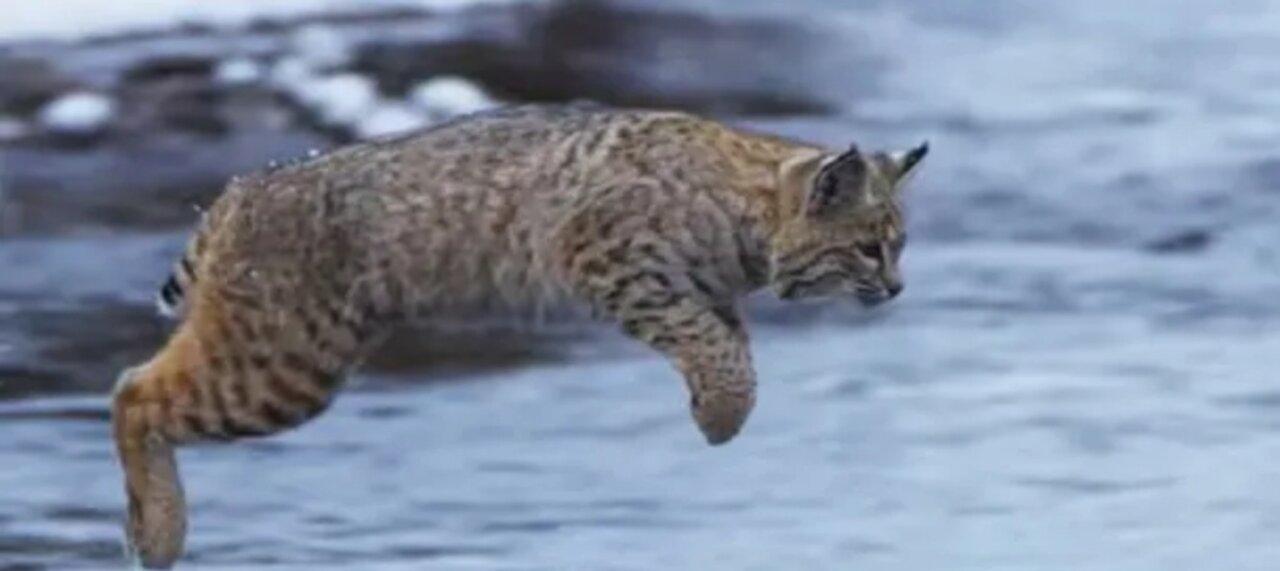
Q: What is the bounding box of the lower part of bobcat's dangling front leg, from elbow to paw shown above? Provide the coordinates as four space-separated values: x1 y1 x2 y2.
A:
617 300 755 444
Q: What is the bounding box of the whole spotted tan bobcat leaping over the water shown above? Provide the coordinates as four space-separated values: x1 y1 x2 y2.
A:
113 104 928 568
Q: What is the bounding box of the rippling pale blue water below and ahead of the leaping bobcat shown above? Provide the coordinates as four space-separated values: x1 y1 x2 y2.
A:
0 0 1280 571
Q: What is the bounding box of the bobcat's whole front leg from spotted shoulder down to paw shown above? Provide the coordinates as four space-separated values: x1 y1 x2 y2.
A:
553 181 755 444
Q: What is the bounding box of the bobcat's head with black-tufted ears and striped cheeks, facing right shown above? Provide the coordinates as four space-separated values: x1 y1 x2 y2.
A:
771 145 928 306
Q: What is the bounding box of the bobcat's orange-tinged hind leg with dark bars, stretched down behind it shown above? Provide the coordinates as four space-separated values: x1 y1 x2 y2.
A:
111 291 371 568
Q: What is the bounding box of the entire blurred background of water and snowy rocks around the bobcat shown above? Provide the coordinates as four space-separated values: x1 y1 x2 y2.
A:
0 0 1280 571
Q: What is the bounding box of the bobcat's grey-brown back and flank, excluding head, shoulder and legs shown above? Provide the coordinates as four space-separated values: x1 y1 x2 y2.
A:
165 105 796 321
